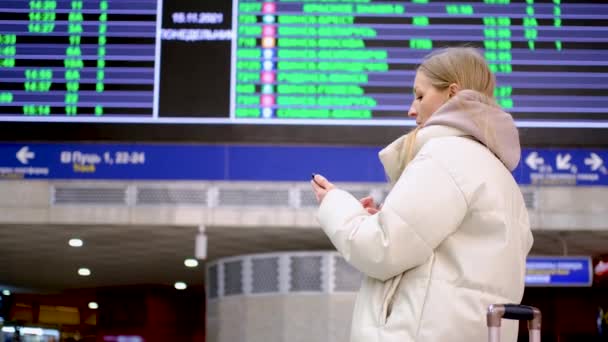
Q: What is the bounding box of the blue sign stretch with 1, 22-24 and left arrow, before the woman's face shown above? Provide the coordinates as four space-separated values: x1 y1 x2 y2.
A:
0 143 386 182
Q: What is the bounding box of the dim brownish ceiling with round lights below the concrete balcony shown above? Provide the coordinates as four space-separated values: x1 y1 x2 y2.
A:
0 225 608 291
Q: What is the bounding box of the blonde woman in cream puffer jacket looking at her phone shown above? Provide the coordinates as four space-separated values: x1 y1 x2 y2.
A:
311 48 533 342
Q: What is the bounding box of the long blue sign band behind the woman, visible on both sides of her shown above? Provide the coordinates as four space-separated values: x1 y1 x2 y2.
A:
0 143 608 186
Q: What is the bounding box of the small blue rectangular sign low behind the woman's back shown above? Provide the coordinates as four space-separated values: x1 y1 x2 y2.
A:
526 257 593 286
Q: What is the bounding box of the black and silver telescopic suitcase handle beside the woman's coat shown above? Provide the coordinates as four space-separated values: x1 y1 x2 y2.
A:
486 304 542 342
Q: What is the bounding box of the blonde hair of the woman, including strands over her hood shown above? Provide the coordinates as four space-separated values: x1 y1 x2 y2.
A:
399 47 496 173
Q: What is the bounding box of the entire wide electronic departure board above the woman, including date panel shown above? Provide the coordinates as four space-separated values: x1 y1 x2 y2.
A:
0 0 608 128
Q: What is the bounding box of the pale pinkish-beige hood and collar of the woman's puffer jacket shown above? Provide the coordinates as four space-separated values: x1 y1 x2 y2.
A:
379 89 521 182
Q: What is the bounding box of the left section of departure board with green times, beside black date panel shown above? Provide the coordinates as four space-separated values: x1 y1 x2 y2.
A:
0 0 157 120
